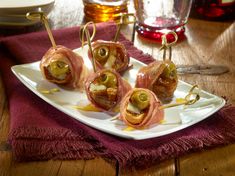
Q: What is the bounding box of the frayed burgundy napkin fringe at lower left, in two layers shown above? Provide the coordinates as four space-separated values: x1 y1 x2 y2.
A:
9 127 106 161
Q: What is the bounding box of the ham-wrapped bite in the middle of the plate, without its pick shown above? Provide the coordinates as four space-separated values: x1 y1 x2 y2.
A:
85 69 131 112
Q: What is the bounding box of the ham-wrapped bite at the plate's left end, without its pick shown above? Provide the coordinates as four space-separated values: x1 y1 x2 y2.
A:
40 45 88 88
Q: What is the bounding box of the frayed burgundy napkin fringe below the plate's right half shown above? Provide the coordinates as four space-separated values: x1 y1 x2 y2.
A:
105 105 235 169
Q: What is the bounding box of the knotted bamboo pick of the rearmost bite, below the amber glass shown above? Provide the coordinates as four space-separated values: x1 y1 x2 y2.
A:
113 13 136 42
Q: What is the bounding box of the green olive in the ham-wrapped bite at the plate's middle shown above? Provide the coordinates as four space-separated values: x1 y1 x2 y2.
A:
99 72 117 87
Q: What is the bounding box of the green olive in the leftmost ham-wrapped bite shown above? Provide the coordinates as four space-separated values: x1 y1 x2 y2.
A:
49 61 69 77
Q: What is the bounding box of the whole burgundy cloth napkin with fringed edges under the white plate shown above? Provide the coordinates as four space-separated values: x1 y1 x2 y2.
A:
0 23 235 168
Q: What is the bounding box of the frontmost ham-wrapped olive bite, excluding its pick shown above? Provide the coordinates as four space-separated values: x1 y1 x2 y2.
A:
119 88 164 129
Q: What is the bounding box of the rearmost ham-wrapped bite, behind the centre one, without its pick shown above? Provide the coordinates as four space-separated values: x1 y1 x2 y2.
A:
88 40 130 73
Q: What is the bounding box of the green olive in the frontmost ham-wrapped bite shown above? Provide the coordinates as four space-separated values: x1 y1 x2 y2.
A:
131 90 150 110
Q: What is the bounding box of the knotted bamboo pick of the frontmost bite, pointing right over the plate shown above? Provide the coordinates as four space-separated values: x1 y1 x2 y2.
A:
110 85 200 121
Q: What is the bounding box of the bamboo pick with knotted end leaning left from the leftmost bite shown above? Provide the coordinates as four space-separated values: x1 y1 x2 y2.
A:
26 11 56 48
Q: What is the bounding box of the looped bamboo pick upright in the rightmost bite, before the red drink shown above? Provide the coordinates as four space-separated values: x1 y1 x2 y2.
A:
160 31 178 60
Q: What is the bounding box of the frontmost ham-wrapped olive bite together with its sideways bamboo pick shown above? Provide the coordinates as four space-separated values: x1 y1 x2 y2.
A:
118 85 200 129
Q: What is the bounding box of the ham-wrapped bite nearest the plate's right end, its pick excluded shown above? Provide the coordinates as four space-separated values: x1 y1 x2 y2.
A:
135 60 178 103
